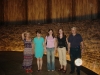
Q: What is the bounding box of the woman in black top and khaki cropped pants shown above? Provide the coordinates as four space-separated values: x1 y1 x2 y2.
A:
57 29 68 73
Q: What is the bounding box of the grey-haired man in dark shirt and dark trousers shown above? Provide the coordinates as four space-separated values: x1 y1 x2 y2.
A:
68 27 83 75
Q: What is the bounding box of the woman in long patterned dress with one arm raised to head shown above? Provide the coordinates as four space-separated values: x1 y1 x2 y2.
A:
22 32 33 73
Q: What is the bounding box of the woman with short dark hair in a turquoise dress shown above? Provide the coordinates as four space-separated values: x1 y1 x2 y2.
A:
33 30 44 72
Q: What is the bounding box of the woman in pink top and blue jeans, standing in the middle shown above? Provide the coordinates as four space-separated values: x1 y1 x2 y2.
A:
45 29 56 71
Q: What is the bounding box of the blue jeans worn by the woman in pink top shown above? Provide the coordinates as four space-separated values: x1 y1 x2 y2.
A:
47 48 55 70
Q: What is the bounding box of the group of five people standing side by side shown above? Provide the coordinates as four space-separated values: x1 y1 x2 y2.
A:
22 27 83 75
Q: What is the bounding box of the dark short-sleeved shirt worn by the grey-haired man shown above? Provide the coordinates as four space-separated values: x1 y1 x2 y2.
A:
68 34 83 48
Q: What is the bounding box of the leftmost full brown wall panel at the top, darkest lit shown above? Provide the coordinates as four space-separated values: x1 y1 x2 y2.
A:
4 0 27 22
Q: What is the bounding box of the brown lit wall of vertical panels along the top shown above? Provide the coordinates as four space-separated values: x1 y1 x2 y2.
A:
0 0 100 23
